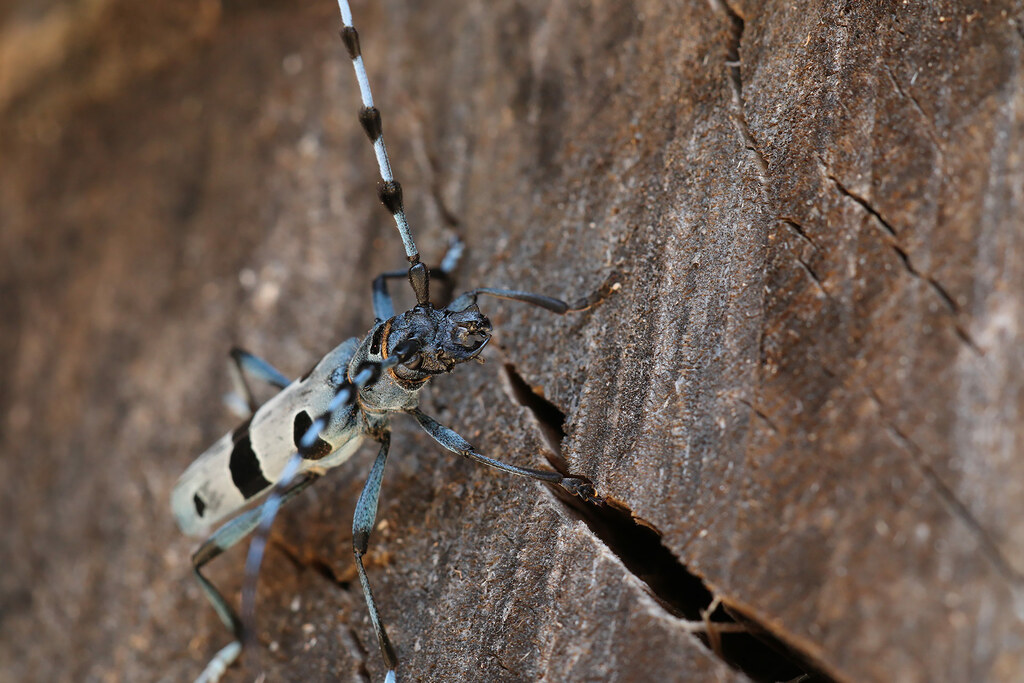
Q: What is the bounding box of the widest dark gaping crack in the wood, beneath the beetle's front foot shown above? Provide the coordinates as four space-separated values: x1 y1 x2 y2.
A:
504 364 835 682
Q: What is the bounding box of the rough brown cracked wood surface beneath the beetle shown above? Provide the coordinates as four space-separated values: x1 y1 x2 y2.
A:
0 0 1024 681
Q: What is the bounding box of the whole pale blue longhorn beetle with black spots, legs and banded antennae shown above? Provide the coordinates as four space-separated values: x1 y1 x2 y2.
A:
171 0 601 683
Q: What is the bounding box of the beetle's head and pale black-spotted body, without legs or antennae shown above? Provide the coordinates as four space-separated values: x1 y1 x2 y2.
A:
171 305 490 536
